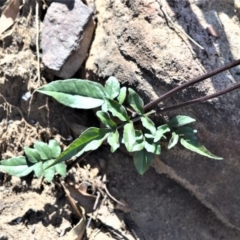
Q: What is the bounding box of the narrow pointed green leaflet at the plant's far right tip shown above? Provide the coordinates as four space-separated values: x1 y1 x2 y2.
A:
180 138 223 160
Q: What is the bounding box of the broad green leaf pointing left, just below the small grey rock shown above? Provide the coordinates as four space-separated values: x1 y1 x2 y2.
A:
37 79 105 109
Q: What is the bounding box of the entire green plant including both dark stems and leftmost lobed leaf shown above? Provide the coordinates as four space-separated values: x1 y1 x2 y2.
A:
0 59 240 178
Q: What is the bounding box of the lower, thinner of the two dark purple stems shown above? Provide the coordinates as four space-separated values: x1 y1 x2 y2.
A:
160 83 240 113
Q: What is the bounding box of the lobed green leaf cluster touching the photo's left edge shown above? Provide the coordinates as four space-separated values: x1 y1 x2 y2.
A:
0 140 66 182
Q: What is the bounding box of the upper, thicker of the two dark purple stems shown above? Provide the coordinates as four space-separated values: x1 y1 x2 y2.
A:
144 59 240 111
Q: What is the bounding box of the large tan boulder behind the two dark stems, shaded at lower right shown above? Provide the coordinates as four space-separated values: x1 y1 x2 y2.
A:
85 0 240 229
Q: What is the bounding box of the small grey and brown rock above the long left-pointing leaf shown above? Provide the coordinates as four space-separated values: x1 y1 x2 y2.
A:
41 0 95 78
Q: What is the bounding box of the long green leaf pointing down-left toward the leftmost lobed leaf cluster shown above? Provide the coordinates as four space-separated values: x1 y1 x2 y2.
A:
51 127 111 164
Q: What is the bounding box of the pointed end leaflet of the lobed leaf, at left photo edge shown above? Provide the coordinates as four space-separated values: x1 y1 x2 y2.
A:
0 156 34 177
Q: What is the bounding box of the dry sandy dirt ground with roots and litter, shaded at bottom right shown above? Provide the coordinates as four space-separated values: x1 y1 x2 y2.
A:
0 0 240 240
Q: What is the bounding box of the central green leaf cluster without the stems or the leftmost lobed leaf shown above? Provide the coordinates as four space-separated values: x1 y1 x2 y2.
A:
37 77 222 174
